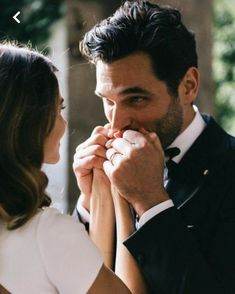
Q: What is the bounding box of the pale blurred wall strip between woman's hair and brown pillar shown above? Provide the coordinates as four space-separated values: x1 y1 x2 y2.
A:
43 18 69 212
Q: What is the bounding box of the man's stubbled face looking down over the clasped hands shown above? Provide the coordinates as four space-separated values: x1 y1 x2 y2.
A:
95 53 187 148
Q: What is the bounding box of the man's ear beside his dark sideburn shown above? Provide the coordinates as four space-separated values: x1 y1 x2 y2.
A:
178 67 200 105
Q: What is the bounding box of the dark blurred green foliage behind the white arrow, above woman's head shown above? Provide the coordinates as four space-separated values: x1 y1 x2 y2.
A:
0 0 64 53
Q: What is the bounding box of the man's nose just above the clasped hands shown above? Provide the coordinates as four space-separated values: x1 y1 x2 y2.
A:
110 108 131 131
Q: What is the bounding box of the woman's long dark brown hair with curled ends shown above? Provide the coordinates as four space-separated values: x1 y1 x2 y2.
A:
0 43 59 229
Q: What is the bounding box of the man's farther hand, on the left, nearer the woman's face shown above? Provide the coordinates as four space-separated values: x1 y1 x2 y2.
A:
73 124 111 211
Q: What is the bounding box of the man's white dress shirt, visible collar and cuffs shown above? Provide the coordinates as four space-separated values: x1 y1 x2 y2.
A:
77 105 206 229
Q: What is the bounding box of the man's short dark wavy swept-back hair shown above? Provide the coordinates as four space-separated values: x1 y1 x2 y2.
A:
80 0 197 95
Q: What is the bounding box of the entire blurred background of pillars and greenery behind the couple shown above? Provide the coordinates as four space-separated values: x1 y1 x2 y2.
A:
0 0 235 212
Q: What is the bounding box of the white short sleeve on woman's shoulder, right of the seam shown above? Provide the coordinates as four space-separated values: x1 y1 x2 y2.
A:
37 208 103 293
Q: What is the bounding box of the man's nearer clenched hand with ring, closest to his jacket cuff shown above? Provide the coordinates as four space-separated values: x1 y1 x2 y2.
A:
104 130 169 216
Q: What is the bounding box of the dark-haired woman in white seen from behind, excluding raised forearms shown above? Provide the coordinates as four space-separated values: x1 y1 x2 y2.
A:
0 44 130 294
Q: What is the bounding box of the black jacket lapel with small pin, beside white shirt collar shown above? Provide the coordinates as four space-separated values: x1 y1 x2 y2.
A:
166 115 229 209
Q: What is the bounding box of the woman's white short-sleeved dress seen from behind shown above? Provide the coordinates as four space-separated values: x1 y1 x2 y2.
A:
0 208 103 294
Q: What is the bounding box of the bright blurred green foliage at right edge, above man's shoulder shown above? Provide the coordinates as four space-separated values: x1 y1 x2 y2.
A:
213 0 235 134
